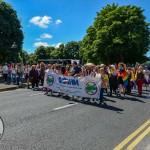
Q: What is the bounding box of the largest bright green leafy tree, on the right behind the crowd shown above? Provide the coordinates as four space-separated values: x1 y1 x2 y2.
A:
80 4 150 64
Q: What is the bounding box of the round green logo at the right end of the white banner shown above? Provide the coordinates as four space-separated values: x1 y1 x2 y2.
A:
85 82 98 95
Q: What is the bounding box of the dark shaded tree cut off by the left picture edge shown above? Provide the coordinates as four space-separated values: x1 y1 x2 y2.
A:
0 1 24 63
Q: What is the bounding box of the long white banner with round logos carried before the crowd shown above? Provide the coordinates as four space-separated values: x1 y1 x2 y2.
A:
44 73 101 99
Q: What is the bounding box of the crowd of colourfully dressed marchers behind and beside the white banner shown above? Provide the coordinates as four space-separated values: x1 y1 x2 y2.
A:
0 62 150 104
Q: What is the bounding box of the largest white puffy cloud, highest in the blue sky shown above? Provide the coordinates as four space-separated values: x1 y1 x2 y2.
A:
30 16 52 28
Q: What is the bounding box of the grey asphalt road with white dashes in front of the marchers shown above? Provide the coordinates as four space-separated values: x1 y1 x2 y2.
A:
0 89 150 150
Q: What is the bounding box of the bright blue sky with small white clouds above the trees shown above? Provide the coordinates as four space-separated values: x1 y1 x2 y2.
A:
4 0 150 55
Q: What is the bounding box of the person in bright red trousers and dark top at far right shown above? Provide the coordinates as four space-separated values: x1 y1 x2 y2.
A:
136 66 144 96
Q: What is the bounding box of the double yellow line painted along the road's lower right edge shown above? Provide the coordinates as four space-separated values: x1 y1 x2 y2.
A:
114 119 150 150
